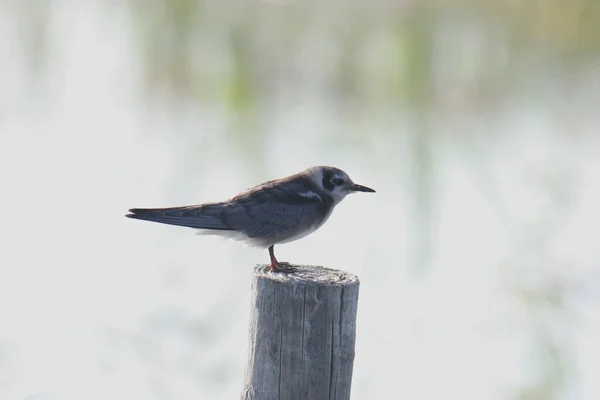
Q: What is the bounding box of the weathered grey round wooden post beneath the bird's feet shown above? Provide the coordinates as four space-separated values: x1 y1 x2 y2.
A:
242 265 359 400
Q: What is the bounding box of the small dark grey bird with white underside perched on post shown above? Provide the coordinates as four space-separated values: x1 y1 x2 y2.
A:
125 166 375 272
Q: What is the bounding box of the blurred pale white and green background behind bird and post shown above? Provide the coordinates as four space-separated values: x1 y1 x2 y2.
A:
0 0 600 400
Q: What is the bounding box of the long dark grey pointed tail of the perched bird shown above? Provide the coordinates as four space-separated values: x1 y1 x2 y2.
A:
125 203 231 230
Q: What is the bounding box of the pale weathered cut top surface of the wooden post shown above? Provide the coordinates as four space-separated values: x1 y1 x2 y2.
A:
254 265 359 286
